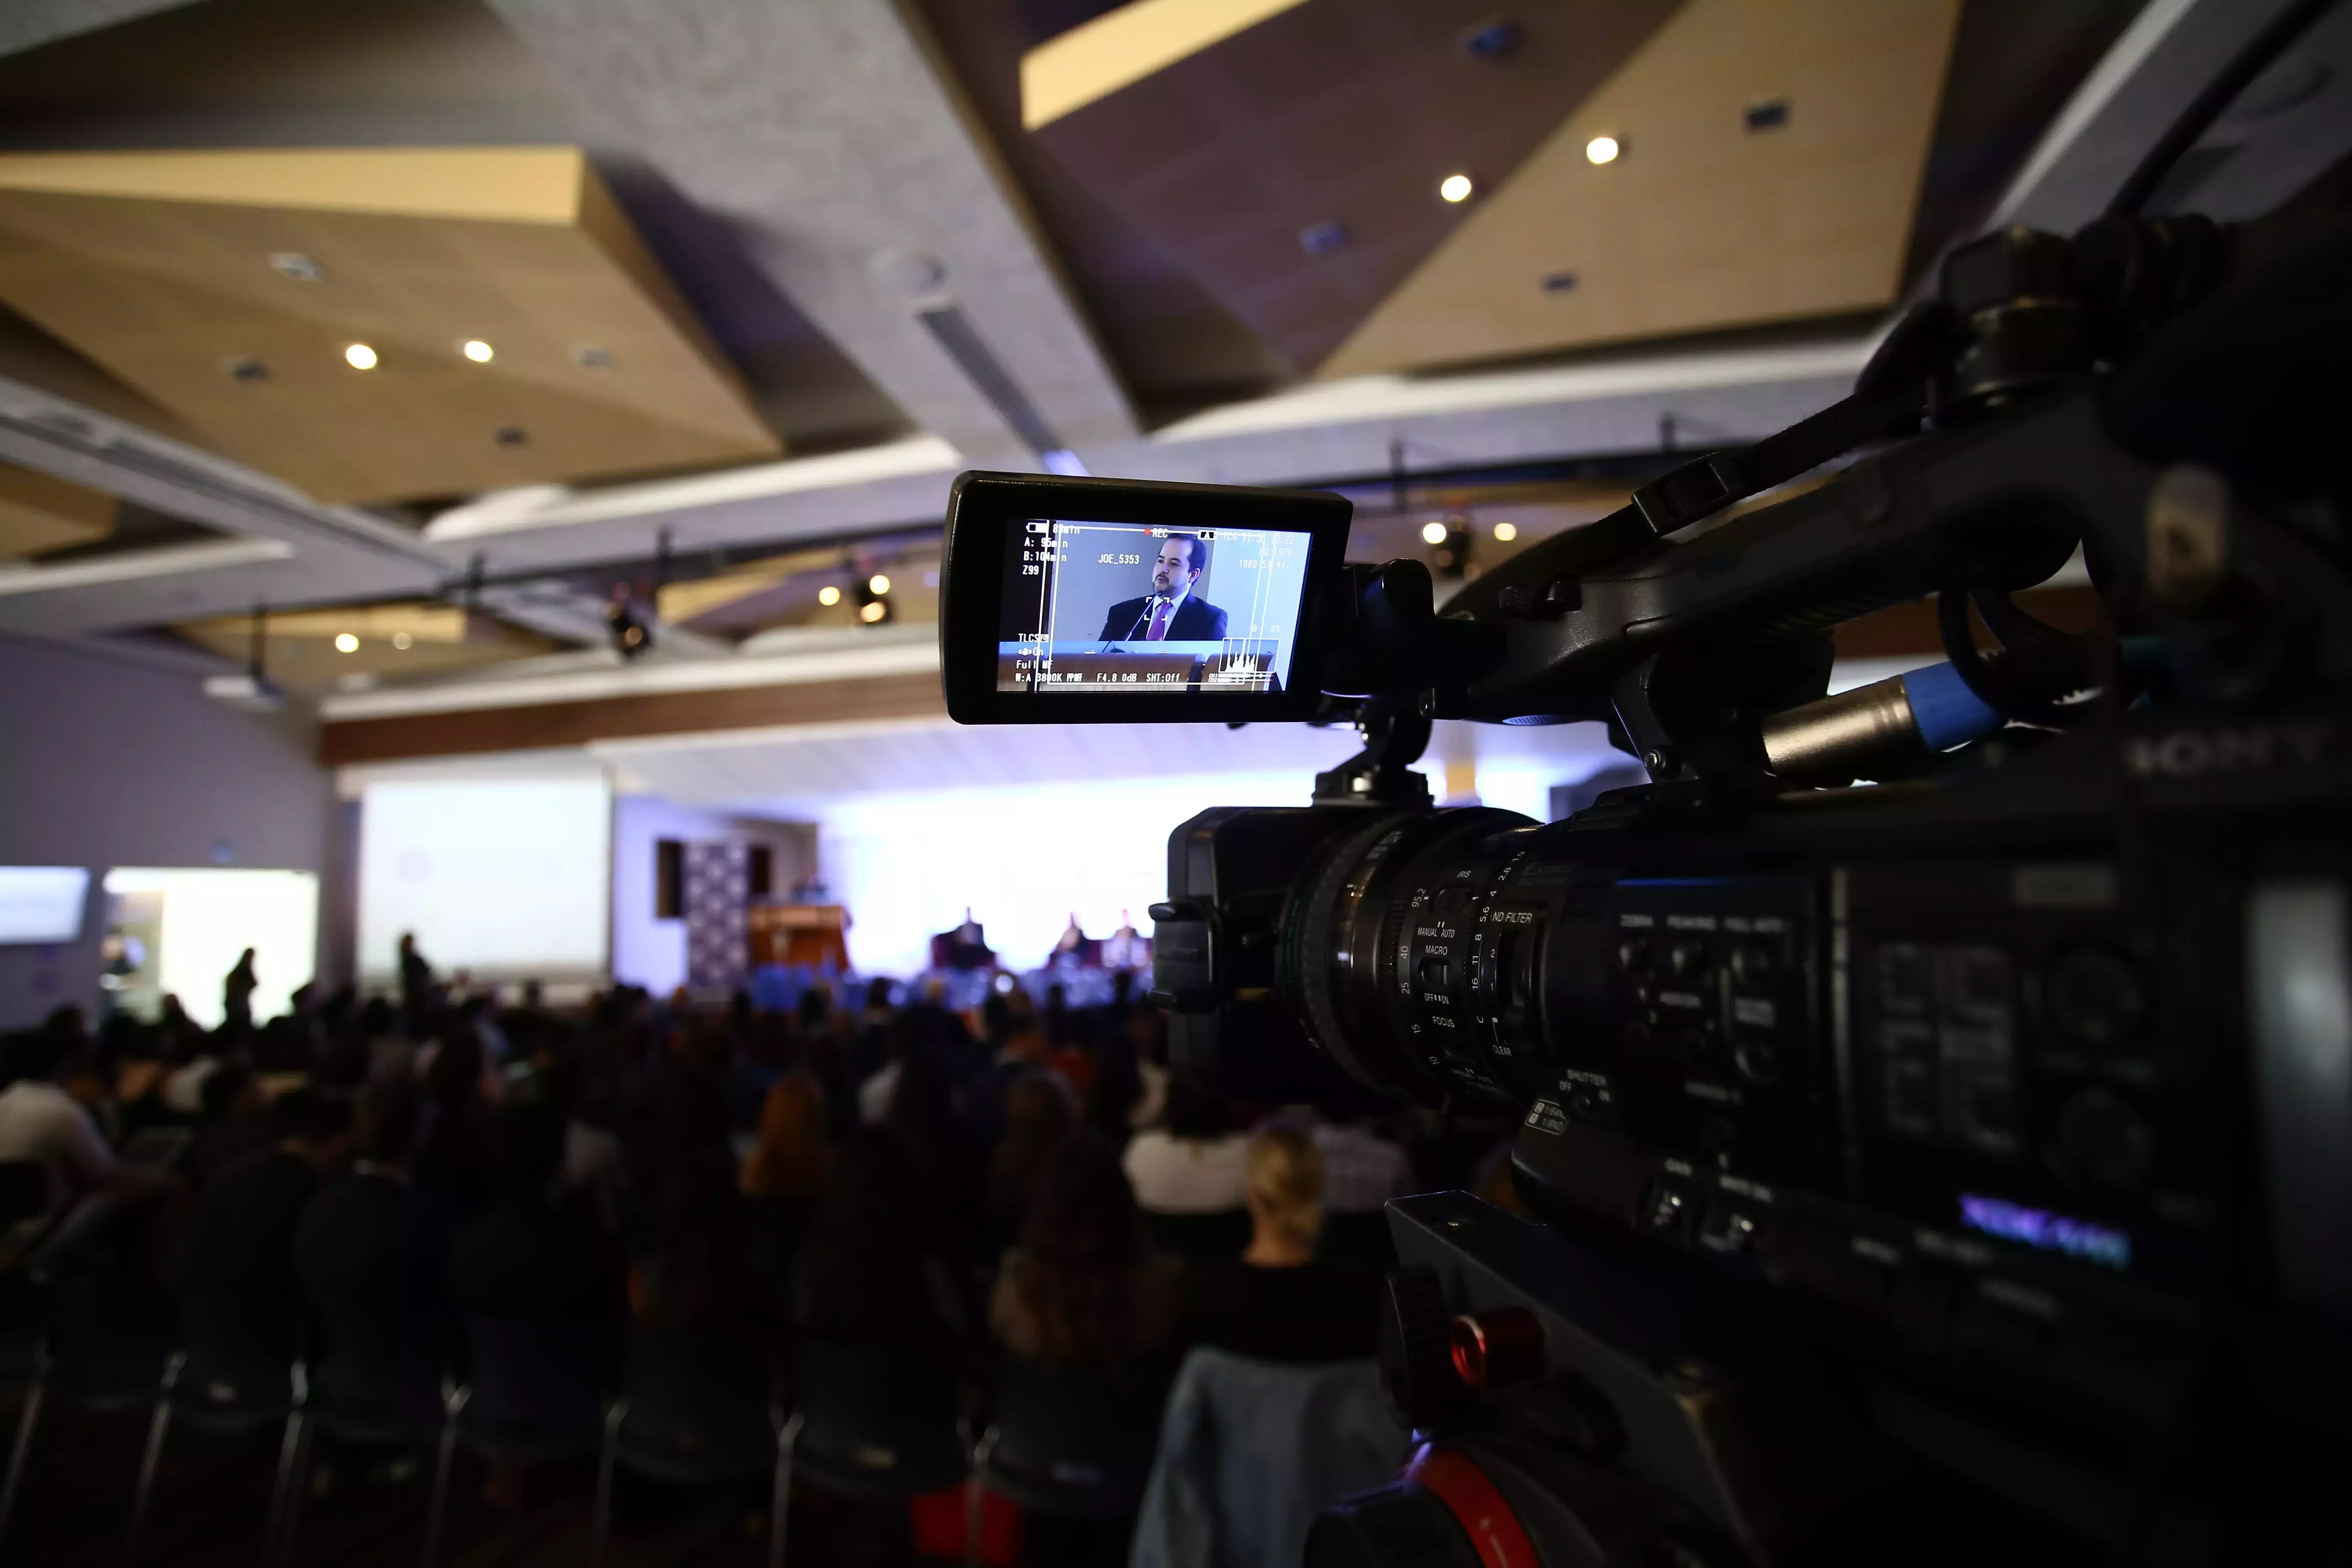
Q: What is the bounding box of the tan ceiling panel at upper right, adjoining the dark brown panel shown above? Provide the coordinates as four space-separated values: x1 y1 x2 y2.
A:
1322 0 1959 376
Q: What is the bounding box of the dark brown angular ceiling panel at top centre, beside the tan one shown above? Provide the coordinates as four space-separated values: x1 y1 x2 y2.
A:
1032 0 1677 369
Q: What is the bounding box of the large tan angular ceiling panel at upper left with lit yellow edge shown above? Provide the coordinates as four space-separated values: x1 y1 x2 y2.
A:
0 148 778 501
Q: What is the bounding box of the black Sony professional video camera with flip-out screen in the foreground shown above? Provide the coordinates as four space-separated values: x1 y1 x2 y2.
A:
941 107 2352 1568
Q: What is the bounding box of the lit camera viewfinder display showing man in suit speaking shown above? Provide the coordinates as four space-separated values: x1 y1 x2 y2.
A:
997 517 1312 701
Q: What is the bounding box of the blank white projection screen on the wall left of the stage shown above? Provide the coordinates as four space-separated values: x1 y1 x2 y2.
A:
360 778 612 985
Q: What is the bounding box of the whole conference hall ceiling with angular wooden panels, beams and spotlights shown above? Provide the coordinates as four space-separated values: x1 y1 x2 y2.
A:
0 0 2286 743
